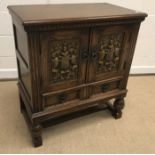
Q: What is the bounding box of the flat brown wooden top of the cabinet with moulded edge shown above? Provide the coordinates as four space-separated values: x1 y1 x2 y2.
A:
8 3 147 25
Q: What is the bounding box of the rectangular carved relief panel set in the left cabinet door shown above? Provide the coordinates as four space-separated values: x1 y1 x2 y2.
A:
49 39 80 83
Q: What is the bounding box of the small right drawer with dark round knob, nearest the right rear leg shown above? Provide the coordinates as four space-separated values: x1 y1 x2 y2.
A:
93 80 120 94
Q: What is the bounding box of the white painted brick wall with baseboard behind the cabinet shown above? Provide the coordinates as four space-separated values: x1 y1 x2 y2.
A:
0 0 155 79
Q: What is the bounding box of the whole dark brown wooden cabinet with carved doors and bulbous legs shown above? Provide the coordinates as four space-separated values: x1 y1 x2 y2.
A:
8 3 147 146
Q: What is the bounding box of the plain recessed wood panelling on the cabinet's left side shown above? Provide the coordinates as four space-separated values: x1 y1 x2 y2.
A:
13 23 32 101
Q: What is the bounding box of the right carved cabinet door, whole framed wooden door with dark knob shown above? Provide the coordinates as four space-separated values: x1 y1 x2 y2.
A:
87 25 130 82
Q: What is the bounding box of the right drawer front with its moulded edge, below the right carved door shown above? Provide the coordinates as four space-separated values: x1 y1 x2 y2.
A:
89 80 121 96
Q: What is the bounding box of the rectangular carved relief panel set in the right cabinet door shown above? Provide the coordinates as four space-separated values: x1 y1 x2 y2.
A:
97 33 123 73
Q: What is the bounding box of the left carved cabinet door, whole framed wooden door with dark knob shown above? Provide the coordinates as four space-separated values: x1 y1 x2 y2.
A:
40 29 88 92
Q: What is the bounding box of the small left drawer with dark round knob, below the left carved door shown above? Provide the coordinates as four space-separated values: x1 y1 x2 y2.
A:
44 90 80 107
